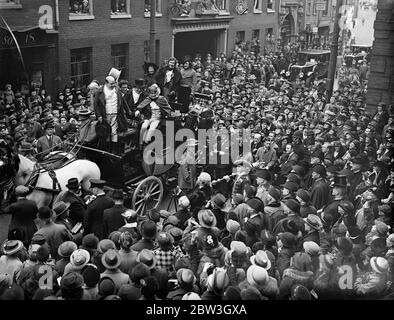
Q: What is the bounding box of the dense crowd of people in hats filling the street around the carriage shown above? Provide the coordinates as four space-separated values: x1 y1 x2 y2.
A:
0 40 394 300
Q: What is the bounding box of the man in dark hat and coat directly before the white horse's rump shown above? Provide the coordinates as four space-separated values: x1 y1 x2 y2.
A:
59 178 86 225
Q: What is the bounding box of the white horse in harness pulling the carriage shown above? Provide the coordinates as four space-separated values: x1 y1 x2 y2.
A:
14 154 101 207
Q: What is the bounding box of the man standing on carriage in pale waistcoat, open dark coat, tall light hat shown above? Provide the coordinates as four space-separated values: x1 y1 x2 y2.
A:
93 76 127 151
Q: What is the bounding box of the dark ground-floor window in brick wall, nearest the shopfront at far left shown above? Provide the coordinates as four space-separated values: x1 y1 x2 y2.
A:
71 48 92 87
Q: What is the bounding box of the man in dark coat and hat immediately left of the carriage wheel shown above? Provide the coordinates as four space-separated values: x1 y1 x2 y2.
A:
103 189 127 238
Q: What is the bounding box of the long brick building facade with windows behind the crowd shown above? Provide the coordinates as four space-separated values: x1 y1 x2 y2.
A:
0 0 280 94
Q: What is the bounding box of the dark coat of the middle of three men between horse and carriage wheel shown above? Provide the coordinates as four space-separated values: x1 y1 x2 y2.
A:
84 195 114 239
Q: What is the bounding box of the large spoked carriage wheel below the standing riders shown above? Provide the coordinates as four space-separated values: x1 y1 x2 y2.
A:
132 176 163 216
